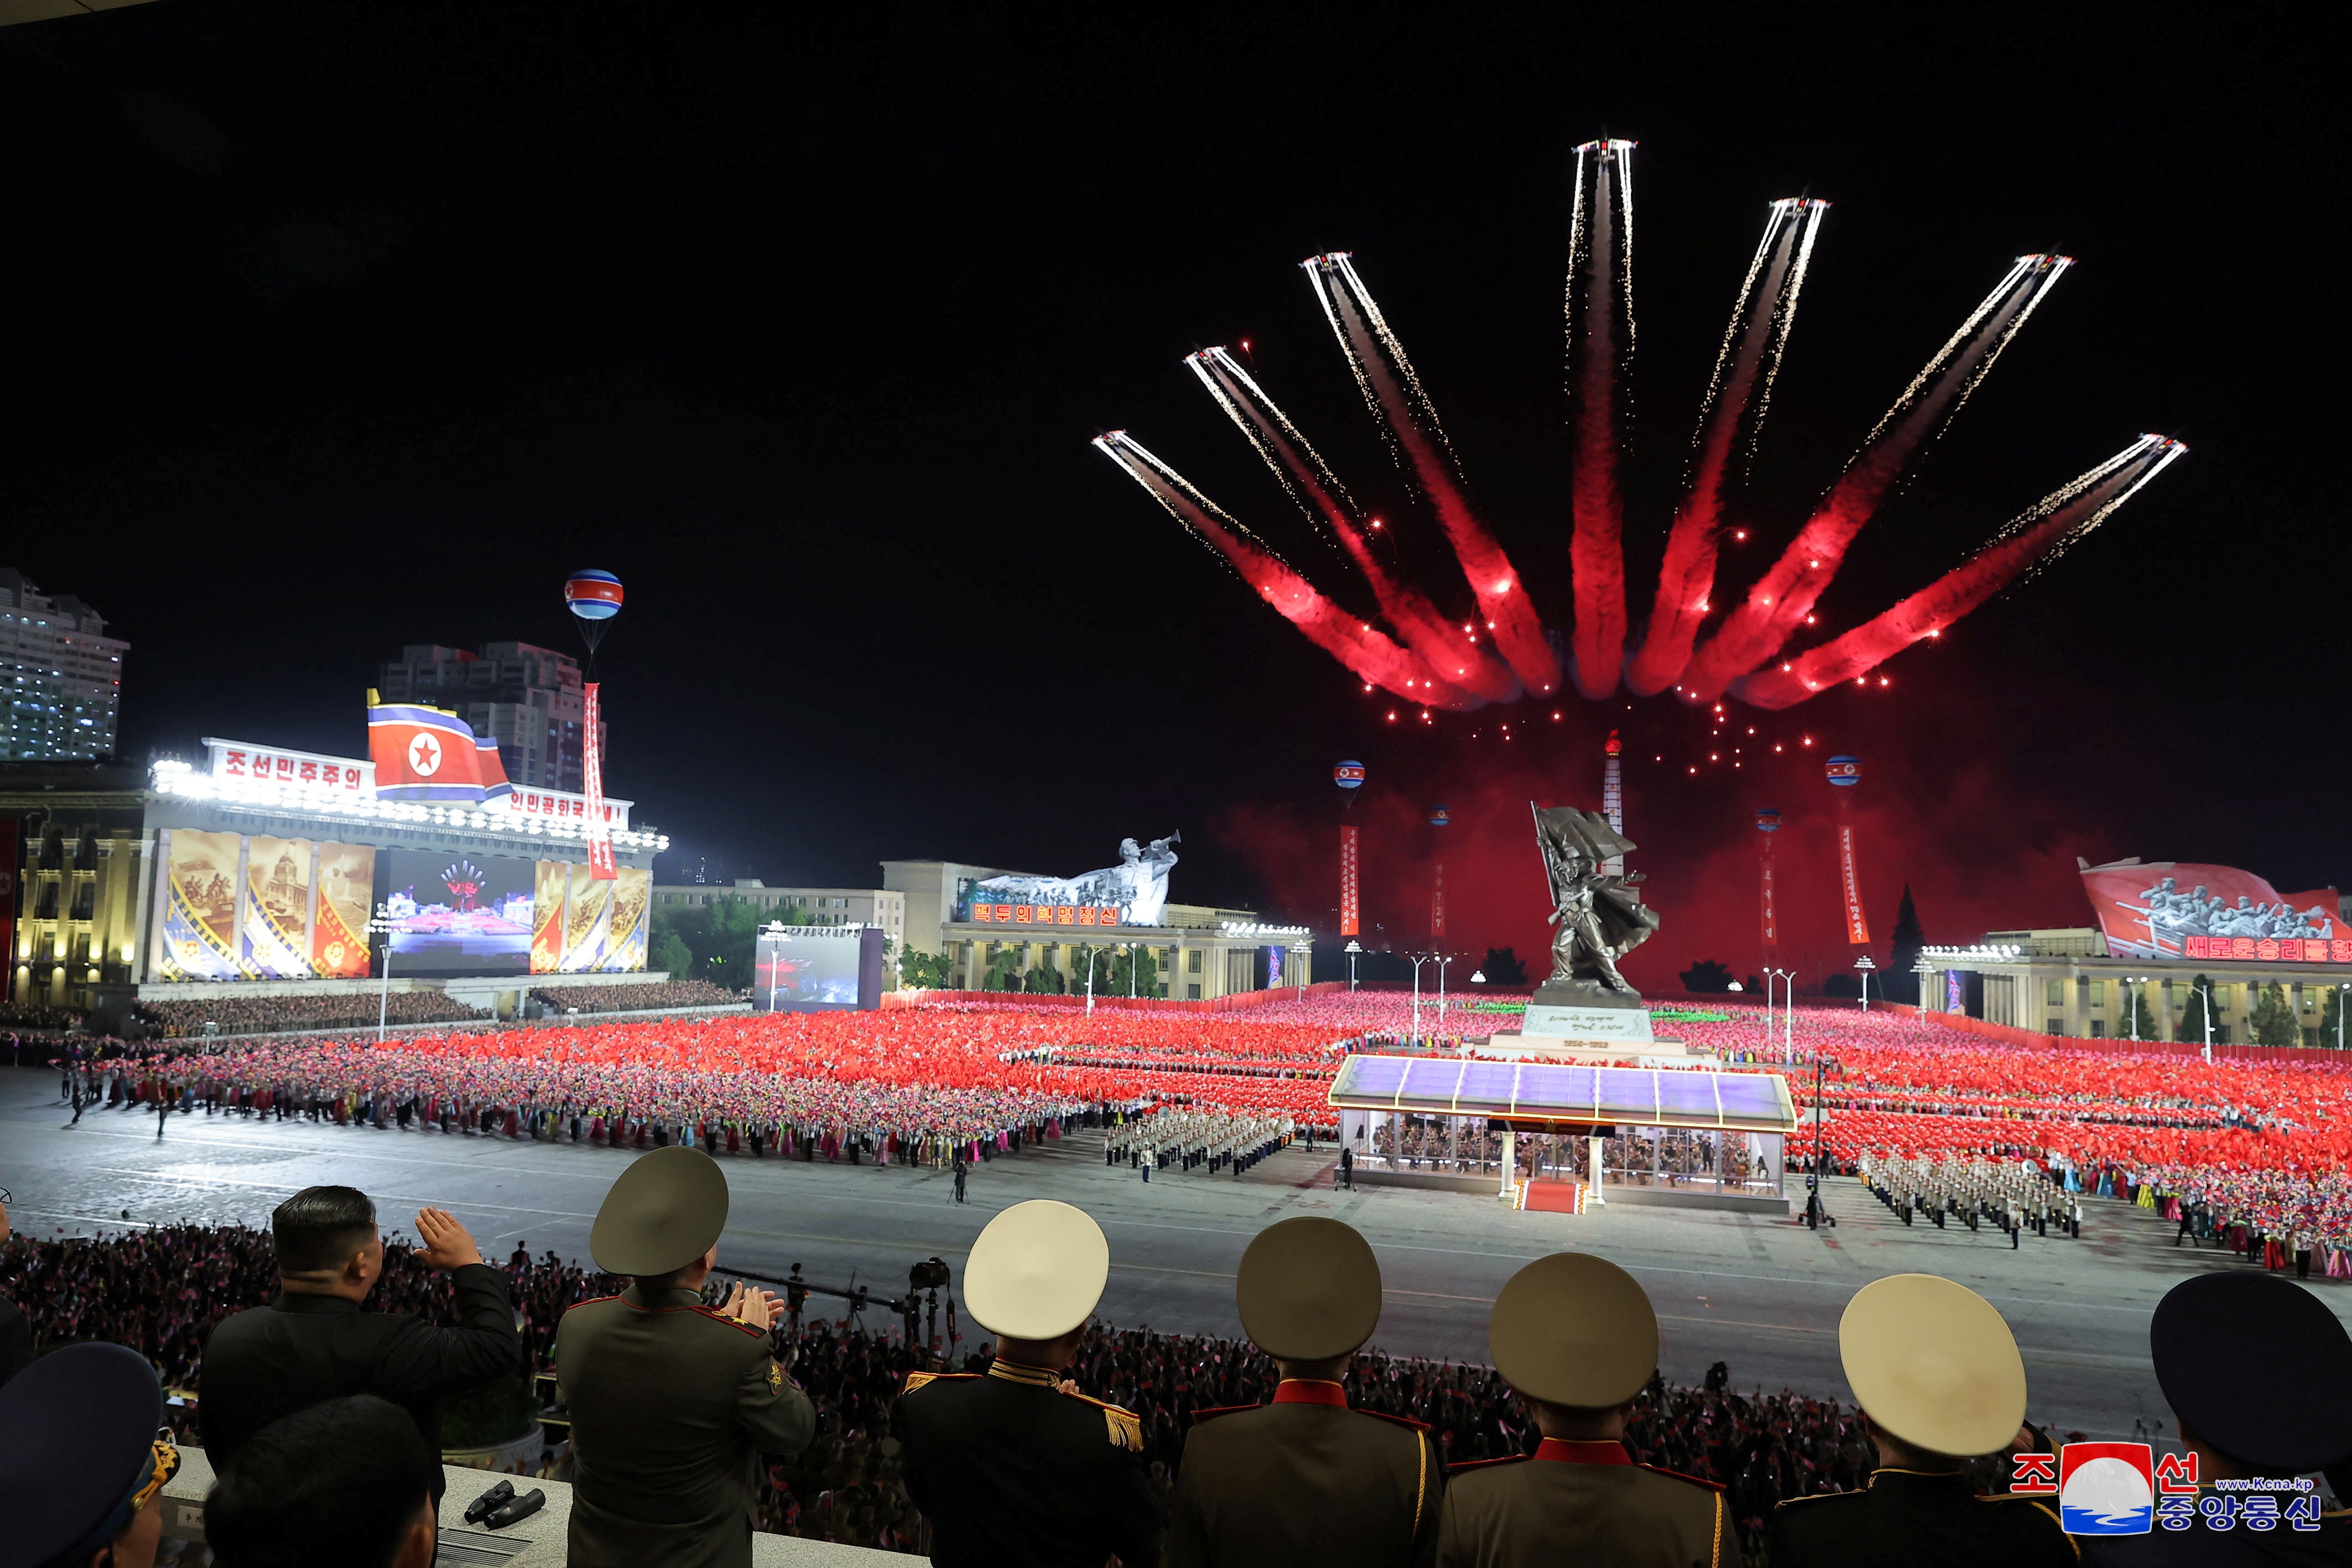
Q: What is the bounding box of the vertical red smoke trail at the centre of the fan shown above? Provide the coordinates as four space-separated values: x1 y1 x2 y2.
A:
1562 141 1635 698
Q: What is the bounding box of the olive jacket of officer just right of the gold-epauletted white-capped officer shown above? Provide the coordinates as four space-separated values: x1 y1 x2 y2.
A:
1167 1380 1446 1568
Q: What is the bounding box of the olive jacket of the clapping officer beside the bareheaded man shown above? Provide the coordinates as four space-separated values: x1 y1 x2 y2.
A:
555 1286 816 1568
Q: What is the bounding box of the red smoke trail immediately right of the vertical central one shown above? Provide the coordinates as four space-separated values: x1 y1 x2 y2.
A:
1625 197 1830 696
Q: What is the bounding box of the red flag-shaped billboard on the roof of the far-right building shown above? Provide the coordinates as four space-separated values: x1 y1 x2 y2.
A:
2082 861 2352 964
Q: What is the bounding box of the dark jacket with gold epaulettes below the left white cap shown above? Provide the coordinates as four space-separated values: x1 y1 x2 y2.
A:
892 1361 1159 1568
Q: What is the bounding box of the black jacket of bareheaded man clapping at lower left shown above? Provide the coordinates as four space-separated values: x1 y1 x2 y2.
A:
195 1262 522 1497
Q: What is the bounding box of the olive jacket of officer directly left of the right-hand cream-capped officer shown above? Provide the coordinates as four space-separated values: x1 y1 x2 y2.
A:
1437 1436 1731 1568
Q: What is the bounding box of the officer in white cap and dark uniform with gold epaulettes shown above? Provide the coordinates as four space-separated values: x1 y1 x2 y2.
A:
892 1199 1159 1568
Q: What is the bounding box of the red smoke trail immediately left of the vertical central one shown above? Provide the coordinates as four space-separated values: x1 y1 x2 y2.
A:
1298 252 1559 696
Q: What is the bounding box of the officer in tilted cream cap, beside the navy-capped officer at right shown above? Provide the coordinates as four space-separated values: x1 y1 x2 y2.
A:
1769 1274 2077 1568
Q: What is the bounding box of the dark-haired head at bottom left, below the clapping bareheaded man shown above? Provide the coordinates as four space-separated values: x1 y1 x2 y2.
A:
205 1394 440 1568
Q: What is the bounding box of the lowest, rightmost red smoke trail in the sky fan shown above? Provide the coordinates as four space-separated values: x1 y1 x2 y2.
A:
1731 435 2187 707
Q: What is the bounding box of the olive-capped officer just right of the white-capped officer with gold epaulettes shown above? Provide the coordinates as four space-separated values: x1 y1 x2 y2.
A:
1167 1218 1444 1568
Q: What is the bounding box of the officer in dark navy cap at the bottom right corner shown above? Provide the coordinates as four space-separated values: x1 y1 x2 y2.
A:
2082 1274 2352 1568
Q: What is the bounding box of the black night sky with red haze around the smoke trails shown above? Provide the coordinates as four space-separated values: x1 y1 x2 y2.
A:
0 0 2352 985
